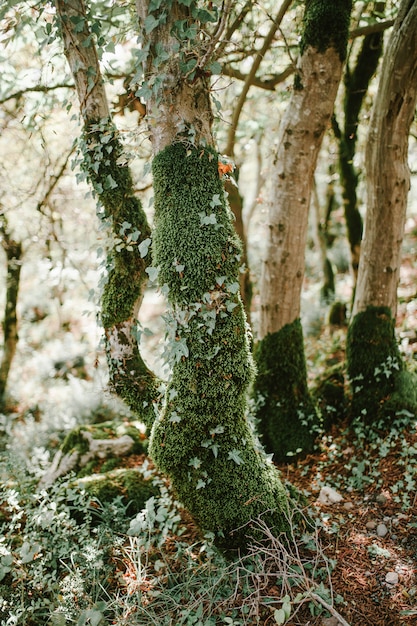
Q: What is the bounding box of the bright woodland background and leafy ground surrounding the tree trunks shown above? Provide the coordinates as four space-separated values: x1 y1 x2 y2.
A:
0 0 417 626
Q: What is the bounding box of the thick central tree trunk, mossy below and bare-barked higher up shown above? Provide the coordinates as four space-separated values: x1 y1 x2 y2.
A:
137 1 287 549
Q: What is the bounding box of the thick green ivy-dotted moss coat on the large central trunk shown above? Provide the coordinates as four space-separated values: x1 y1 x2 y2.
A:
150 144 287 549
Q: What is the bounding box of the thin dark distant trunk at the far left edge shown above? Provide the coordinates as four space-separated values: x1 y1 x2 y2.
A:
0 215 22 408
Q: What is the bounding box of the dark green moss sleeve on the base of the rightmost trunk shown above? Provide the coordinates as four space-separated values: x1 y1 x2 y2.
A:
346 306 417 425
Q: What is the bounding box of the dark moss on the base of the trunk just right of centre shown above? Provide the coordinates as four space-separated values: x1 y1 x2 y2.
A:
253 319 320 462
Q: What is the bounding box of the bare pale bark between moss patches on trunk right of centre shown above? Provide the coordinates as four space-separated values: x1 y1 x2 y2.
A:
260 47 342 338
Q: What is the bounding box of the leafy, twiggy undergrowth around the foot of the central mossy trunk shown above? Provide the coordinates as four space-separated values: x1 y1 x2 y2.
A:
0 444 341 626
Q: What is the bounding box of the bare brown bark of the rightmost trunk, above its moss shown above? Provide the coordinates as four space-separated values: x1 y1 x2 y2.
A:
353 0 417 317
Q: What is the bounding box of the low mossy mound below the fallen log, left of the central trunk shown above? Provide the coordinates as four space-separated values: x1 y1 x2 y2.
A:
78 469 159 515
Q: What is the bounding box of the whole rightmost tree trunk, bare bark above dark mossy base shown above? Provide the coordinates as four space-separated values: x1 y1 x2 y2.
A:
347 0 417 424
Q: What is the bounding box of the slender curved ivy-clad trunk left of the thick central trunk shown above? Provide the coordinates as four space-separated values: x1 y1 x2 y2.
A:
55 0 158 426
